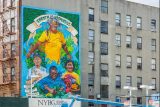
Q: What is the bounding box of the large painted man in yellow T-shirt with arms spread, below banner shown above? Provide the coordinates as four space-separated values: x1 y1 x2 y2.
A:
27 18 71 64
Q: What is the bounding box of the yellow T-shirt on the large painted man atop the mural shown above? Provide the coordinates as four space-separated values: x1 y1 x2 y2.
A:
38 31 66 63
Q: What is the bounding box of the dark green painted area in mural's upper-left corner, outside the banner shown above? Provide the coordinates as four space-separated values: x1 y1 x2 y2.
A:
23 8 46 42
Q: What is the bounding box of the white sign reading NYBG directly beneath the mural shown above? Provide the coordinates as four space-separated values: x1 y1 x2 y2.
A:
29 98 81 107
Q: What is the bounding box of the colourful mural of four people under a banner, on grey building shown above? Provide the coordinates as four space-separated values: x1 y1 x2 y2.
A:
21 7 81 98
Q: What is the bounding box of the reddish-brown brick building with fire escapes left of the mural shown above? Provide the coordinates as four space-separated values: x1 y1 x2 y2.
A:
0 0 20 97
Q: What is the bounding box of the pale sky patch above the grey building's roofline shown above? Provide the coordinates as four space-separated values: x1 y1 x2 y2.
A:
128 0 159 7
